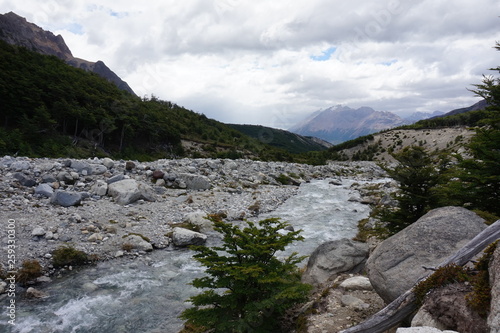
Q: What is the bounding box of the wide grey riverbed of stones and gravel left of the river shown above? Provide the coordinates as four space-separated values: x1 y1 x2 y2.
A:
0 156 389 332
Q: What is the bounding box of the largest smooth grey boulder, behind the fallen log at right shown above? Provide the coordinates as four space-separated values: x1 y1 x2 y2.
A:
366 207 486 303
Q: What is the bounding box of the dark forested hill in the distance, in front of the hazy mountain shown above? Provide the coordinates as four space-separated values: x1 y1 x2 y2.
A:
229 124 332 153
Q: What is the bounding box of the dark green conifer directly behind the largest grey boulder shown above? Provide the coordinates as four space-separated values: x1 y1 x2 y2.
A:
380 146 446 234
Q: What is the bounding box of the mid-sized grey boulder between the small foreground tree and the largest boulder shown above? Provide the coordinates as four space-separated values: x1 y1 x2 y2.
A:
302 238 368 286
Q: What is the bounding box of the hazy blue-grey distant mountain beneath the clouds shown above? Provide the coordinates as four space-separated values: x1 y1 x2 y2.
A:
289 105 407 144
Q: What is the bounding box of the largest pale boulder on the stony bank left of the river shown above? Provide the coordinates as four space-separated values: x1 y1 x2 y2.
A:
108 179 156 205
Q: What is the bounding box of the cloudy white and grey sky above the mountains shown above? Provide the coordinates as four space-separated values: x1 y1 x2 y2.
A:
0 0 500 129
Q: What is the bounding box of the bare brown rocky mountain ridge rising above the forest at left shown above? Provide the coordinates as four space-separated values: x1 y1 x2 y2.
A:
0 12 134 94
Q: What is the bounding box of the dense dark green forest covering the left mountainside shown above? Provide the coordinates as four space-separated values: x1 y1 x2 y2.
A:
0 41 308 161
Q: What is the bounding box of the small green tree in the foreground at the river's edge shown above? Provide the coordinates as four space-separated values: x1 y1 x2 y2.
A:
180 218 311 333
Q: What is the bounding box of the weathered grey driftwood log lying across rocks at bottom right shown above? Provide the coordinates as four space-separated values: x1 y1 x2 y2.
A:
341 220 500 333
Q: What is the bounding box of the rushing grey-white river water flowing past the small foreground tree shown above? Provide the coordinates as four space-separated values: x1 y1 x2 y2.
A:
0 179 378 333
